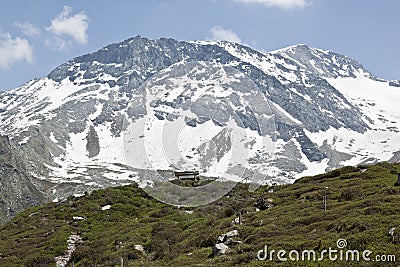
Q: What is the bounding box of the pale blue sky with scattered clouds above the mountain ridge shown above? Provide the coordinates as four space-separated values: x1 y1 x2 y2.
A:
0 0 400 90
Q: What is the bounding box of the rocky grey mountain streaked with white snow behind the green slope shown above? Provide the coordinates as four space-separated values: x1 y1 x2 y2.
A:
0 36 400 209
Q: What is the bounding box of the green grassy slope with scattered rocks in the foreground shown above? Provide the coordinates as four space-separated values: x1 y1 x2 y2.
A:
0 163 400 266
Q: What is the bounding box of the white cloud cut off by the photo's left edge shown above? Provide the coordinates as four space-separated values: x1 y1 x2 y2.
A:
0 34 33 69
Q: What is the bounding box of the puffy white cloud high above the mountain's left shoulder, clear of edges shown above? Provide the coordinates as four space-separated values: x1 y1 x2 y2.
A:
46 6 89 50
